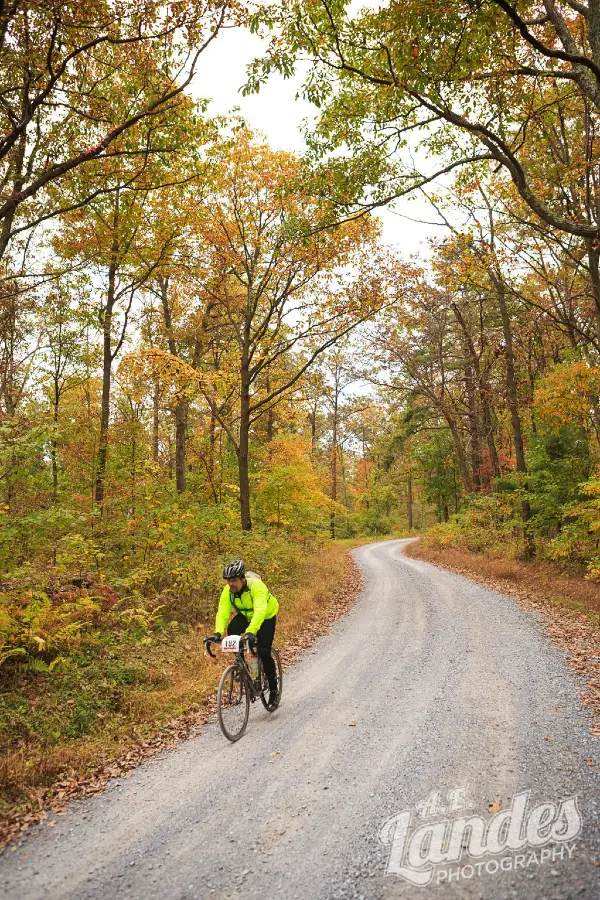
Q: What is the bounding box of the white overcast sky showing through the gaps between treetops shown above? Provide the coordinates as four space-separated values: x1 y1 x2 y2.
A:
193 28 442 258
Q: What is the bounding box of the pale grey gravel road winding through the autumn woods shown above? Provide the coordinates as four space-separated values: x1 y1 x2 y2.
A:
0 541 600 900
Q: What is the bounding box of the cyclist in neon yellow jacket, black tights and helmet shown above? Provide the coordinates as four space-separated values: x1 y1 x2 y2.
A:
209 559 279 709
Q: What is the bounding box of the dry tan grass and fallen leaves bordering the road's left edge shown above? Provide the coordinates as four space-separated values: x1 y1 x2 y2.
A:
0 541 362 847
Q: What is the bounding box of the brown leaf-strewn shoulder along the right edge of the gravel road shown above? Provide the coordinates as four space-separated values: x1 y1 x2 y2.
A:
404 538 600 738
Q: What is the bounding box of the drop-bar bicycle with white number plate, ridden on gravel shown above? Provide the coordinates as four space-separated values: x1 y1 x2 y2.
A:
204 634 283 742
